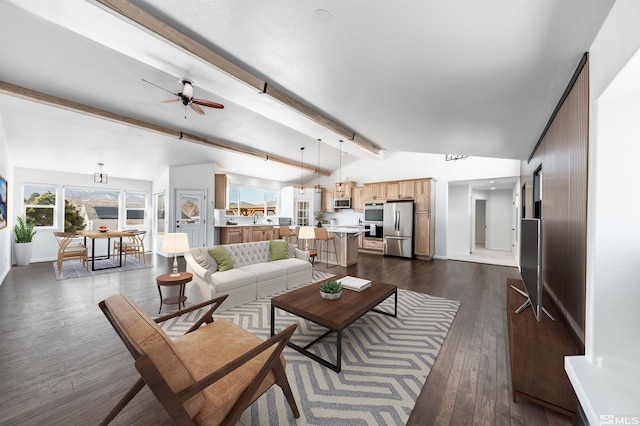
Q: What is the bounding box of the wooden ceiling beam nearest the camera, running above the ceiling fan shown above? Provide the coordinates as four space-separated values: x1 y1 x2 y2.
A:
95 0 380 155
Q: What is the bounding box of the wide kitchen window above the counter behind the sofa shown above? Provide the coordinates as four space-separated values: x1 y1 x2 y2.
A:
226 185 278 216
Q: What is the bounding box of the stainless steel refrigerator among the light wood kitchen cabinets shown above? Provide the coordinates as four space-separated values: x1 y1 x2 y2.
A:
383 200 413 258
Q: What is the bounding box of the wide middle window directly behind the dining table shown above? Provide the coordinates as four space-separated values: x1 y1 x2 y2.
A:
65 187 120 229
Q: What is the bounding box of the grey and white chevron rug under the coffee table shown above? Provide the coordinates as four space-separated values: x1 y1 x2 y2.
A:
163 275 460 426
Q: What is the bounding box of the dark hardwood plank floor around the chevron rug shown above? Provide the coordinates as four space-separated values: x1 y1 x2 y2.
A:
0 254 571 425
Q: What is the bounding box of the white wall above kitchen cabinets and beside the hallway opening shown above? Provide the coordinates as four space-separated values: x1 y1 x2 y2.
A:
311 152 520 259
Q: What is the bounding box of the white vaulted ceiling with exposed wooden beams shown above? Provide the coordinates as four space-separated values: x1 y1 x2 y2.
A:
0 0 613 182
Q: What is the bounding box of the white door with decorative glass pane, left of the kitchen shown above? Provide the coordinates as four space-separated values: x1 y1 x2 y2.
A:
175 189 207 247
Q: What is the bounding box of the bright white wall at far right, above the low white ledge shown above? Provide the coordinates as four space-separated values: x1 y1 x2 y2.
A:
586 0 640 368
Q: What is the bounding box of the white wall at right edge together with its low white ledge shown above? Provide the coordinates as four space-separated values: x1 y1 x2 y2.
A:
566 0 640 424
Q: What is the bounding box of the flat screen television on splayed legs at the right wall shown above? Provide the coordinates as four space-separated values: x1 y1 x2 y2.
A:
513 219 553 321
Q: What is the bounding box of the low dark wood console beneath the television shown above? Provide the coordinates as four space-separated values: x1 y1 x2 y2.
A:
507 279 579 417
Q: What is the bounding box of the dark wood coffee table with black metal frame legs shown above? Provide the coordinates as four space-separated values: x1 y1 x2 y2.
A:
271 275 398 373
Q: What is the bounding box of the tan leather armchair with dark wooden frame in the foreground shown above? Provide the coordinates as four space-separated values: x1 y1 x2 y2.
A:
99 294 300 425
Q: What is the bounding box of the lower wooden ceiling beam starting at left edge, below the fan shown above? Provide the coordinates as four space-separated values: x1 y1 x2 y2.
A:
0 81 331 176
